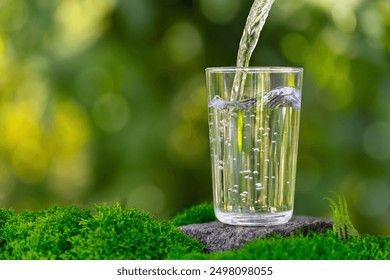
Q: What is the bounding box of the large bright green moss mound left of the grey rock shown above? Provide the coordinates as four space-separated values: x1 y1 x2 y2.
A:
0 205 203 260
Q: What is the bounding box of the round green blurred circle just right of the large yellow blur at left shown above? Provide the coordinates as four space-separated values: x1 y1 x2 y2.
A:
92 93 130 132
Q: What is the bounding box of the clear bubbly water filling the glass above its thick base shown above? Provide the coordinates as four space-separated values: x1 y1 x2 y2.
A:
209 87 299 212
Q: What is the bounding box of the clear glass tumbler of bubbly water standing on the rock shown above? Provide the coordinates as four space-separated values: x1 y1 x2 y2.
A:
206 67 303 226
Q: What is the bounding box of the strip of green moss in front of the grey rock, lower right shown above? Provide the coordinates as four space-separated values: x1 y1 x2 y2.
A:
182 231 390 260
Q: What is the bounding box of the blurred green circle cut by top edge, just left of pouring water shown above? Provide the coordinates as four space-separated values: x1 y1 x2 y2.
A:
200 0 240 23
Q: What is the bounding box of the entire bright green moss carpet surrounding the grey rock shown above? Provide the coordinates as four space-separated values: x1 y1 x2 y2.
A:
0 204 390 260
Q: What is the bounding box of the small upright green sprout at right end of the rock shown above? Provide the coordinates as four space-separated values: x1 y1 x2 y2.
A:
325 192 360 239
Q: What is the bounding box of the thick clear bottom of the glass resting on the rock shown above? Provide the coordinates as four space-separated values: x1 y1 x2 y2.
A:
214 209 293 226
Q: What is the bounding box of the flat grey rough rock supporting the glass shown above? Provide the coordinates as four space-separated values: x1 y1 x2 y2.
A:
180 217 333 252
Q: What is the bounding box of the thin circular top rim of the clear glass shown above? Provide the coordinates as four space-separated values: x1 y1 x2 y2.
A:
205 66 303 73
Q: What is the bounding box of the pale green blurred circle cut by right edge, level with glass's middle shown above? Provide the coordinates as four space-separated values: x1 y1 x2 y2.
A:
363 122 390 160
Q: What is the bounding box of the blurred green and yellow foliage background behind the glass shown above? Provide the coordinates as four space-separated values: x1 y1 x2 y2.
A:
0 0 390 235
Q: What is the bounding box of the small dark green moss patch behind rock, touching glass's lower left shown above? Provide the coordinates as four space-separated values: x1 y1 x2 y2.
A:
171 202 216 226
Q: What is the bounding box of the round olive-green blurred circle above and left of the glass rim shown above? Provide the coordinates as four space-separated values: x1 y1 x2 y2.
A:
164 22 203 63
